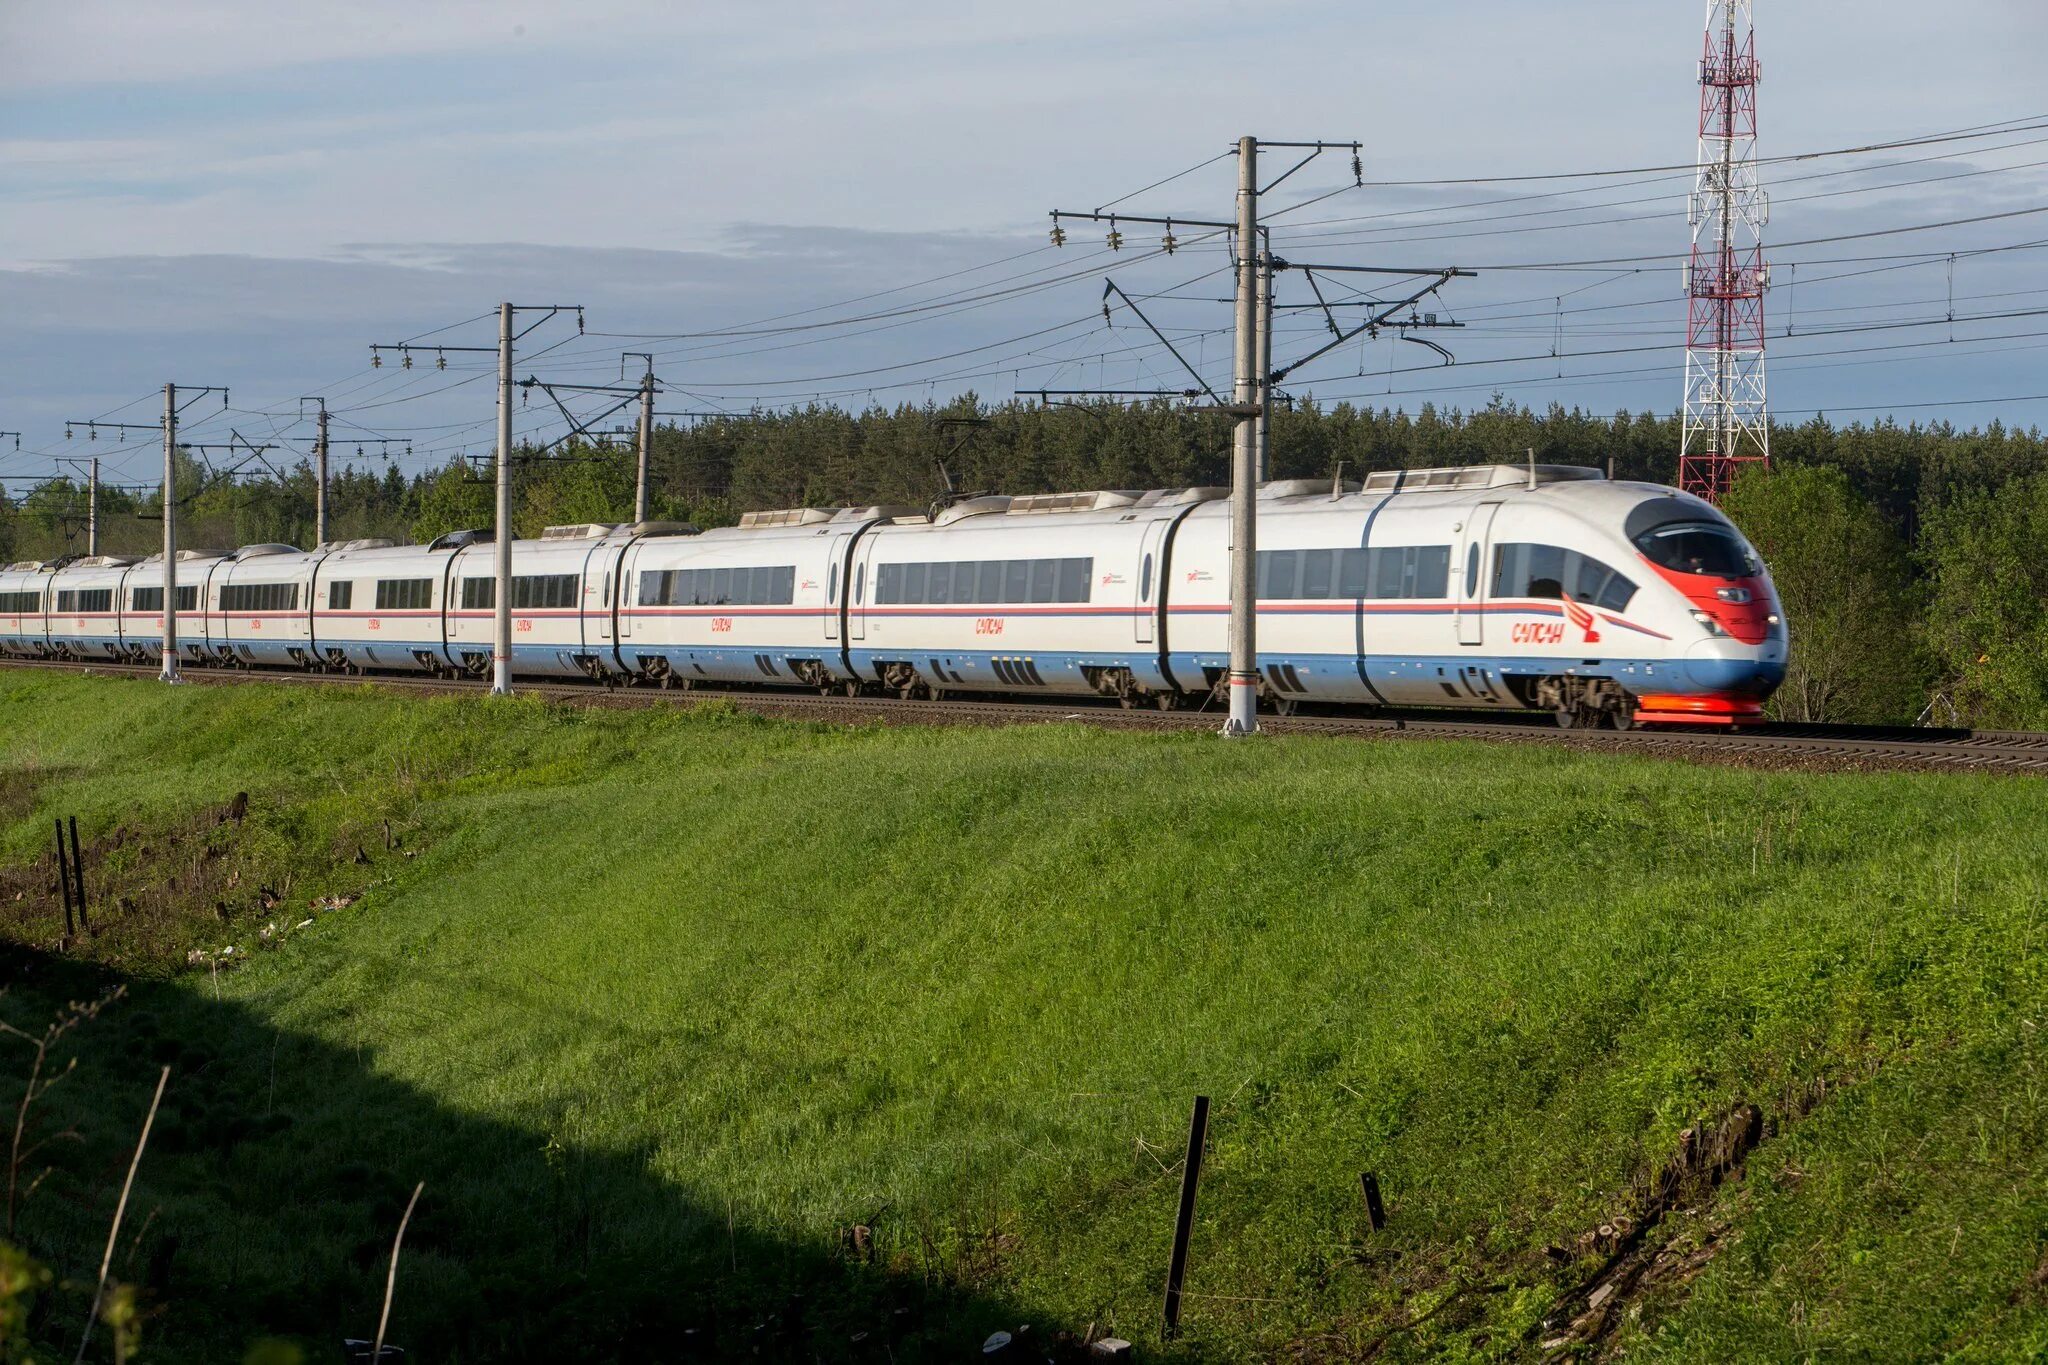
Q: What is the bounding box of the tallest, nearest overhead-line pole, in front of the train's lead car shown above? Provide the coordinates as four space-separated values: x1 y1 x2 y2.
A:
1223 137 1266 739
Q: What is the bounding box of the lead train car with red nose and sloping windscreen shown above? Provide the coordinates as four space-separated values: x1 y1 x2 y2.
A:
1167 465 1786 726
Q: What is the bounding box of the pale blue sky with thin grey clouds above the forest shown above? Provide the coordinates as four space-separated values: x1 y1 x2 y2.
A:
0 0 2048 483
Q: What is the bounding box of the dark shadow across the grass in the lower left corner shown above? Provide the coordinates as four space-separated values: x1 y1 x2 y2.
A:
0 945 1044 1363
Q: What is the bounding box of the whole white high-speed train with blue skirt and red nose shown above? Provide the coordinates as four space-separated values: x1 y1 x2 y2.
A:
0 465 1786 726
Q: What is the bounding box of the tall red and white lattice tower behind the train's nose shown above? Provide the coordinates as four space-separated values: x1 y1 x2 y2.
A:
1677 0 1772 499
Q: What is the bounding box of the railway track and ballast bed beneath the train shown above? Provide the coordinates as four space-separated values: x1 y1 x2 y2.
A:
0 659 2048 774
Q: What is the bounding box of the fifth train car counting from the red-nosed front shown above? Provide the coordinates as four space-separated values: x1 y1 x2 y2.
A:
309 530 456 673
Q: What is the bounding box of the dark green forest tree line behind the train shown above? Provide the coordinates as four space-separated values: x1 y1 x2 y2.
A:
0 395 2048 726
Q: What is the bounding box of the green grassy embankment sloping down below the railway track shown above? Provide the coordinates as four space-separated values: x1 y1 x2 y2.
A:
0 671 2048 1361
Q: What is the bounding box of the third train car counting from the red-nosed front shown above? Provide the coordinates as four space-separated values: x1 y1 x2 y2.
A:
616 508 892 690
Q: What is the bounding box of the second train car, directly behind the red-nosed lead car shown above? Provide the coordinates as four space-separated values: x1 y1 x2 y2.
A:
846 489 1223 704
